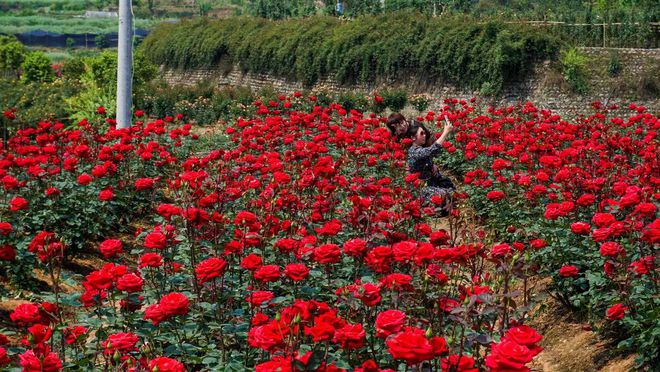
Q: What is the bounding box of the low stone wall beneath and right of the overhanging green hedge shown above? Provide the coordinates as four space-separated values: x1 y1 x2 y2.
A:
163 48 660 115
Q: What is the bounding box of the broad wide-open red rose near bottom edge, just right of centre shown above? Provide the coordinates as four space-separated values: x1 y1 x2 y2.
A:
385 327 448 365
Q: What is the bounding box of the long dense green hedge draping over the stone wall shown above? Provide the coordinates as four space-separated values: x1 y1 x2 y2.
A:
141 12 562 91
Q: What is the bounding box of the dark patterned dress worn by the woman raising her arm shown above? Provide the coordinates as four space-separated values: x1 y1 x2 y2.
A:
408 142 456 212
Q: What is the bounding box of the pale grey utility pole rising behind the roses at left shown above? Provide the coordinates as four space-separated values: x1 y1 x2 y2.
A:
117 0 133 128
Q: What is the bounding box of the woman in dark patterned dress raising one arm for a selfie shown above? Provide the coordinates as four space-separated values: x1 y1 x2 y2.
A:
408 116 456 217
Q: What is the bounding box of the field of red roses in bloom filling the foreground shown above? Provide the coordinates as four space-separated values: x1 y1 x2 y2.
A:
0 93 660 372
